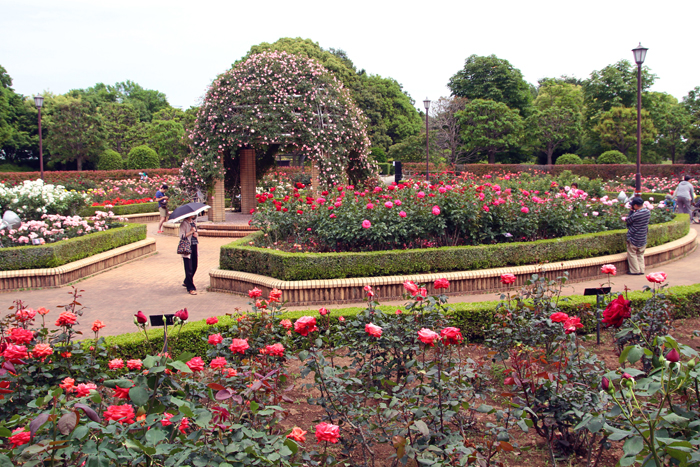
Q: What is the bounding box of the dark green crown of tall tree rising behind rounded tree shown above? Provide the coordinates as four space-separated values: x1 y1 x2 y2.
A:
447 55 533 115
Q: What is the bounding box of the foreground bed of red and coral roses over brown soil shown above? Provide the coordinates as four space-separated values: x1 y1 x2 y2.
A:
0 272 700 467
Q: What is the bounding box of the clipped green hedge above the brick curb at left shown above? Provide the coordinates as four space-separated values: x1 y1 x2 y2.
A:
0 224 146 271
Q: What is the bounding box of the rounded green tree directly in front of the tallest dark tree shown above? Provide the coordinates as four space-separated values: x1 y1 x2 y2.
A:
457 99 523 164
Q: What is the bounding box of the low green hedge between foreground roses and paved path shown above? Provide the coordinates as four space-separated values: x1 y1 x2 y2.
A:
100 284 700 360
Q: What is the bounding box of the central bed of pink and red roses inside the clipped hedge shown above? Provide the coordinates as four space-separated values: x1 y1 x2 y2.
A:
251 174 672 252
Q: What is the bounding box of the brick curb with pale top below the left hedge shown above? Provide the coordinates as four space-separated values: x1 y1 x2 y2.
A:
0 238 156 292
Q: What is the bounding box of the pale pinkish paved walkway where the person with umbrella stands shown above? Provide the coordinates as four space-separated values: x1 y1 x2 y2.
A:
6 223 700 337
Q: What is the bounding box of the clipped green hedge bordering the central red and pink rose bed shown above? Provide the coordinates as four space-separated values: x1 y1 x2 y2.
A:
219 214 690 281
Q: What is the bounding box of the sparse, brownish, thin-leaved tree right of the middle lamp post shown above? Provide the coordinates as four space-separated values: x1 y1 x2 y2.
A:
430 96 469 164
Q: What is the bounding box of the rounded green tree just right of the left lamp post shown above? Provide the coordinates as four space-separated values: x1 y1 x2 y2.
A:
46 96 104 170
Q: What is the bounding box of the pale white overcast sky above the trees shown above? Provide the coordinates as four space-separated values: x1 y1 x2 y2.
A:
0 0 700 108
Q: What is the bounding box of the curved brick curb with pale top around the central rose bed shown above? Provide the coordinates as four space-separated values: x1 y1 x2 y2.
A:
209 229 697 306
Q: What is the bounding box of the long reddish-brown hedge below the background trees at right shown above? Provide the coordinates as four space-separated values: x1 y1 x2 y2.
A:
452 164 700 180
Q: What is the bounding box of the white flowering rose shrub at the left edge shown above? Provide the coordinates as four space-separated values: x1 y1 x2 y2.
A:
0 180 89 221
